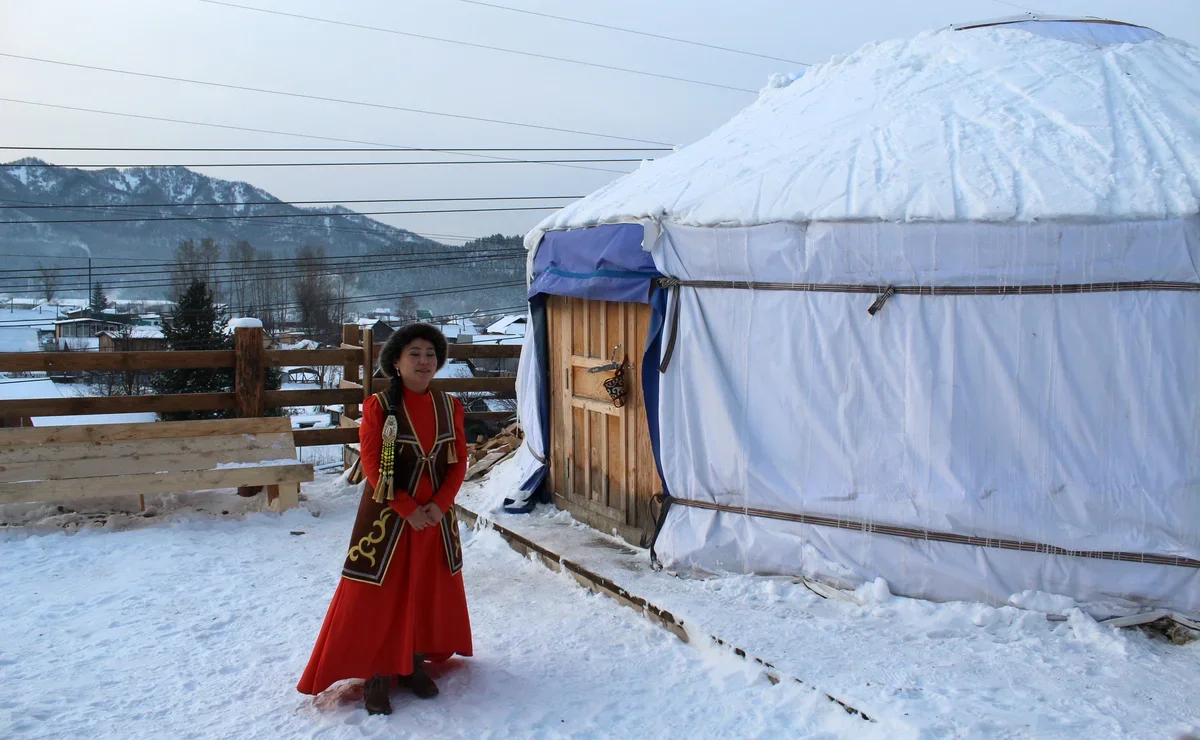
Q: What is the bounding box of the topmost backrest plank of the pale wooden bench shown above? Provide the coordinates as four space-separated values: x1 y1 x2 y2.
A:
0 416 292 443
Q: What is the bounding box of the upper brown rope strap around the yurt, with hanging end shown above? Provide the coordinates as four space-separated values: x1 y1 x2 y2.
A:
659 277 1200 373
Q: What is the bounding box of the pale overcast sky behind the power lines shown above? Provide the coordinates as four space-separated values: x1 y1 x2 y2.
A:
0 0 1200 242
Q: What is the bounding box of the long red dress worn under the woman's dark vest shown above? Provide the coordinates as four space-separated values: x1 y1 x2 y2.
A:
296 389 472 694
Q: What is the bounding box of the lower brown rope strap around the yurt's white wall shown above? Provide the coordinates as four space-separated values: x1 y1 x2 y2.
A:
650 494 1200 568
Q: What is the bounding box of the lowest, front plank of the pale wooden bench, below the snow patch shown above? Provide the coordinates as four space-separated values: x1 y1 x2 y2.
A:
0 463 313 504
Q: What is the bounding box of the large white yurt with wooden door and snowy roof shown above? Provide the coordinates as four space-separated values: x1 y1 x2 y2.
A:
509 17 1200 616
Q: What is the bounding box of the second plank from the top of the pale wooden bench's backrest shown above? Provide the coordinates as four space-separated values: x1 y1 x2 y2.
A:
0 432 295 467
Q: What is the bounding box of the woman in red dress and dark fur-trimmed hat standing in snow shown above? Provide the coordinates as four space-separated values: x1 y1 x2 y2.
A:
296 324 472 715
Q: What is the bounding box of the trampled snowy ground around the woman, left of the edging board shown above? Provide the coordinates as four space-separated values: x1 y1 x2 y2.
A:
0 476 892 739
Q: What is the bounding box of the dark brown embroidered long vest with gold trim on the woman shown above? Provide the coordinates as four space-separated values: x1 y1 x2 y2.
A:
342 389 462 585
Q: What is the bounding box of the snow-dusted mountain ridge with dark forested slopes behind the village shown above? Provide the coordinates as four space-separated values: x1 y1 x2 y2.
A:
0 158 524 312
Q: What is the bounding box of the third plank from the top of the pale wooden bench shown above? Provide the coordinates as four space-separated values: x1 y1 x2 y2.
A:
0 434 295 483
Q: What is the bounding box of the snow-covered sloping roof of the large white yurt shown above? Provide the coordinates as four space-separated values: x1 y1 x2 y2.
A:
540 17 1200 227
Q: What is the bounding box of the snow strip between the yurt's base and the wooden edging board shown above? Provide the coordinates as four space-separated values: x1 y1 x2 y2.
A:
458 461 1200 739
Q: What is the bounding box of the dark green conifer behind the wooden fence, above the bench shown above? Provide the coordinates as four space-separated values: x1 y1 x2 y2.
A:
152 279 234 421
